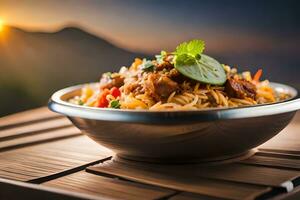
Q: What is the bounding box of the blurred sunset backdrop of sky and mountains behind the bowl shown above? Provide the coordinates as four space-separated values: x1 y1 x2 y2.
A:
0 0 300 116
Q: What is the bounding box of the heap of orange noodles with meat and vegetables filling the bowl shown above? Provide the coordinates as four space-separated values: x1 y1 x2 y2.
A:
69 40 289 110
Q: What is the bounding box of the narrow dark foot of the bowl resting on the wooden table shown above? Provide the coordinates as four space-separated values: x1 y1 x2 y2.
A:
113 149 257 165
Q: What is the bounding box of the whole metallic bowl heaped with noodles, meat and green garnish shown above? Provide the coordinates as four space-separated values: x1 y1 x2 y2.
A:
49 40 300 163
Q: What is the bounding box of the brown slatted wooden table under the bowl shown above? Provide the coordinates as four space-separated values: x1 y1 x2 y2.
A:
0 107 300 200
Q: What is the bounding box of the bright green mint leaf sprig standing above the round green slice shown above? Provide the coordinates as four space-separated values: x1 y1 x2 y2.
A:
175 40 205 57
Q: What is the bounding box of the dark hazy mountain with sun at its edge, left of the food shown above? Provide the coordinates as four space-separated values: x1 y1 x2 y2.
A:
0 27 145 116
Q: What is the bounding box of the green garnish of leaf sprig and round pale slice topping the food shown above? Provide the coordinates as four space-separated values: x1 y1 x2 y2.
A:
174 40 226 85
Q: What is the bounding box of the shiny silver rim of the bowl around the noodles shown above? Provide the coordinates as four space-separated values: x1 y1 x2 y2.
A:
48 82 300 124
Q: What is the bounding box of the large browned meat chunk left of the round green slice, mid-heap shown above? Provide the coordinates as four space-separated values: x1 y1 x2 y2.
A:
145 74 179 101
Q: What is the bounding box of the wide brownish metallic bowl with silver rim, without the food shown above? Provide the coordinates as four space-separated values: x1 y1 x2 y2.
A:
49 83 300 163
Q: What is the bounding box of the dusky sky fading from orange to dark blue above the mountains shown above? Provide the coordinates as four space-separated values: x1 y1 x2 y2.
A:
0 0 300 53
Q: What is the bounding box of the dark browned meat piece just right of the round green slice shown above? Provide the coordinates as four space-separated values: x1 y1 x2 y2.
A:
225 78 256 99
